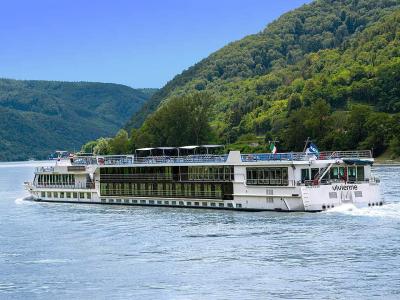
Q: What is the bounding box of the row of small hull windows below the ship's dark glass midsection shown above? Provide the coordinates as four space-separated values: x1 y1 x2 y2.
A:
101 198 242 208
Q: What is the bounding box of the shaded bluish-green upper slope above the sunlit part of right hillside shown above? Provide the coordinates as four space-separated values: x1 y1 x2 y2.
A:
127 0 400 128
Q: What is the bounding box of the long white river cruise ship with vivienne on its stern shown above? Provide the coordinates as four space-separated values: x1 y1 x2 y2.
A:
25 146 383 212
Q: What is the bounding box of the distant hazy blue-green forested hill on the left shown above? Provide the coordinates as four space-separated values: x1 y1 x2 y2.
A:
0 79 154 160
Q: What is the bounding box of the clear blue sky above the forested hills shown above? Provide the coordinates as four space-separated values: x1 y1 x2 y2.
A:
0 0 311 87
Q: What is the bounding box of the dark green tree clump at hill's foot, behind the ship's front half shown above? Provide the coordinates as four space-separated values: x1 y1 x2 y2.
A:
81 93 217 154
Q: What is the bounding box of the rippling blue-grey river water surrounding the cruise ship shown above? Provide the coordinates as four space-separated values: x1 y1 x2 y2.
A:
0 163 400 299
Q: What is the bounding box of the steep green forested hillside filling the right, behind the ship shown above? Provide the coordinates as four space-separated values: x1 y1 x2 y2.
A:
118 0 400 158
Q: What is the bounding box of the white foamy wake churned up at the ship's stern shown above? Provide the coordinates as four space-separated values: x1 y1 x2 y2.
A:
326 202 400 219
